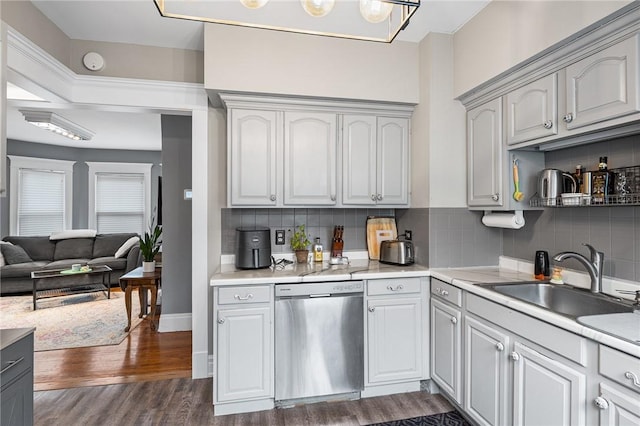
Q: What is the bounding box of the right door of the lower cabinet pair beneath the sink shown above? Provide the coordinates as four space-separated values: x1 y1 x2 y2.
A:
510 342 586 426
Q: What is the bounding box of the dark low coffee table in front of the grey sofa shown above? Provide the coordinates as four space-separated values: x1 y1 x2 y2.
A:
31 265 111 311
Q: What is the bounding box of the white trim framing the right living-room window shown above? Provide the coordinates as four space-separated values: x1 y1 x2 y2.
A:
86 161 153 233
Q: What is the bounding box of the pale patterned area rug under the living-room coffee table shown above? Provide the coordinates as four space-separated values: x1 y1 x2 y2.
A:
0 292 142 351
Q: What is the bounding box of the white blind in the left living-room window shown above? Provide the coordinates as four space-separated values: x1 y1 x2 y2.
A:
18 169 65 236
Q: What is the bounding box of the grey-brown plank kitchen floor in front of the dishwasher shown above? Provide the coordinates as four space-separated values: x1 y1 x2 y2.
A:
34 379 452 426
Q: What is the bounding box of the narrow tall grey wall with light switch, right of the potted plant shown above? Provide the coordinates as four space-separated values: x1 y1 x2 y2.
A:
161 115 191 314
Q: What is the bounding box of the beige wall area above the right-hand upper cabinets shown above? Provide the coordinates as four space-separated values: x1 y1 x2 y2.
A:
454 0 630 96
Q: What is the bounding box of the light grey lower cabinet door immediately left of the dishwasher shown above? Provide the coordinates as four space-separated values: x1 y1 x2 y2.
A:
216 306 273 402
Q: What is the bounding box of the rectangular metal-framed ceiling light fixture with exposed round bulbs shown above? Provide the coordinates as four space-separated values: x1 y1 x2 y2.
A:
153 0 420 43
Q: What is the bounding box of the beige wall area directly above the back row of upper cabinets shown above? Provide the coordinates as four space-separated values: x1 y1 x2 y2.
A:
204 24 418 103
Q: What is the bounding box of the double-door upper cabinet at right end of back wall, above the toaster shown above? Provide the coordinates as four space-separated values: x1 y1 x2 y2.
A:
342 115 409 206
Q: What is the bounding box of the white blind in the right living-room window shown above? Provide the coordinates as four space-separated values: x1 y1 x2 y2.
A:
95 173 145 235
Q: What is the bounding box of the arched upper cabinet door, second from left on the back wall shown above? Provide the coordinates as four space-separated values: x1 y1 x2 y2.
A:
284 112 337 205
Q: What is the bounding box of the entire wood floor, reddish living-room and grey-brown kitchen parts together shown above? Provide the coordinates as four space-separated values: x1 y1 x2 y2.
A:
34 288 452 426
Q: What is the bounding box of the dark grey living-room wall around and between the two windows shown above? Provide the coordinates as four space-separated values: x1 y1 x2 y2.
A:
0 140 161 237
